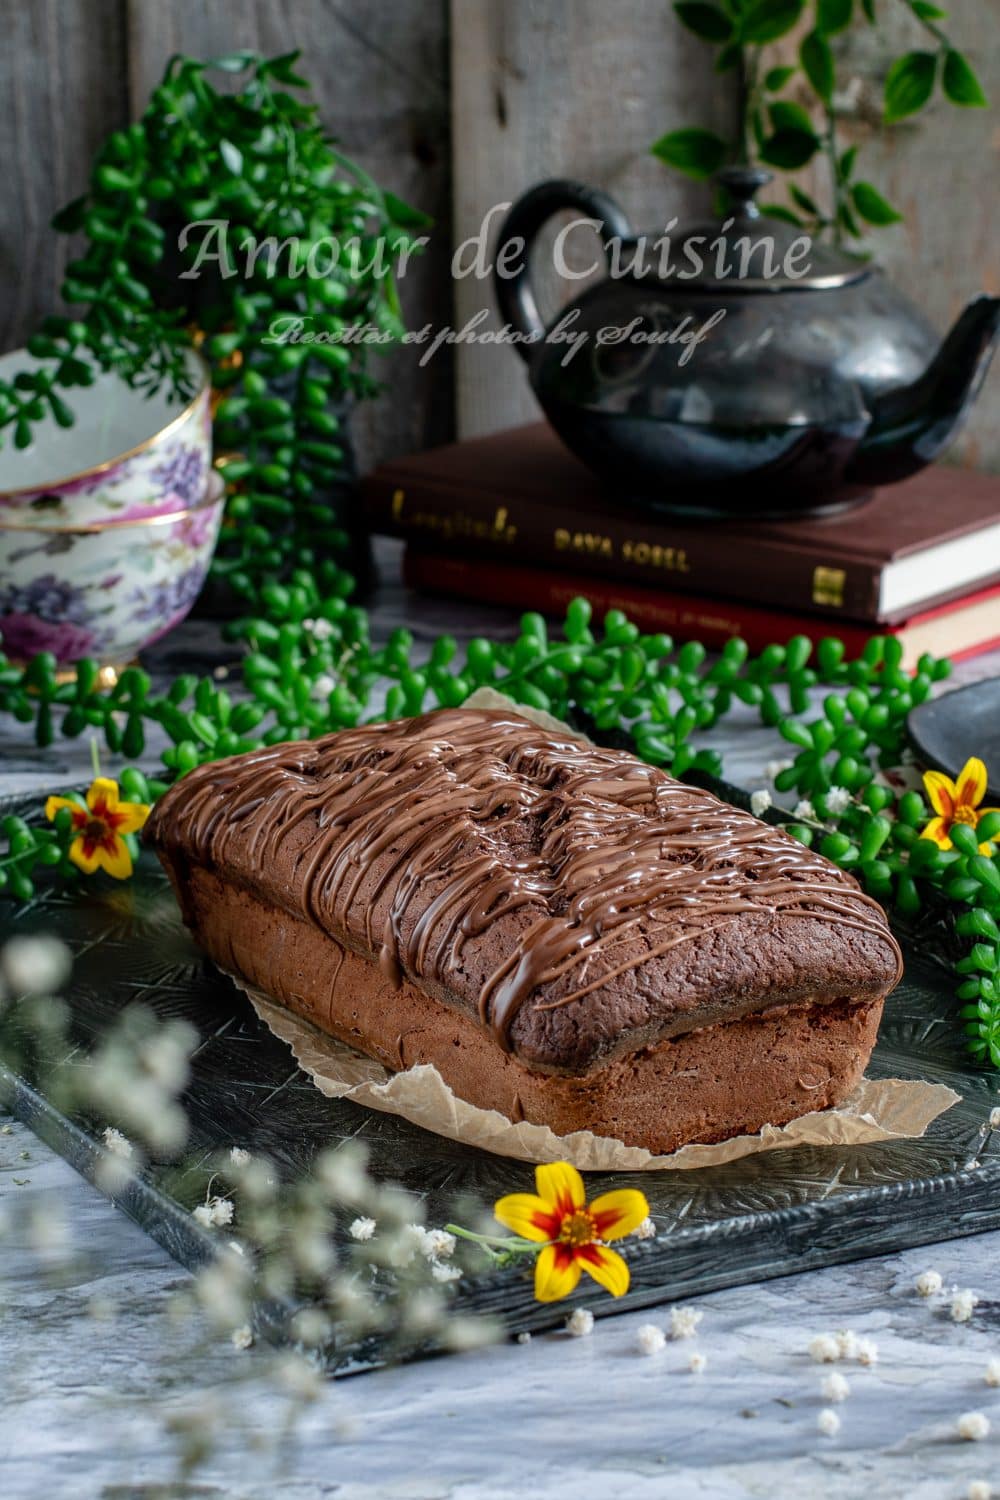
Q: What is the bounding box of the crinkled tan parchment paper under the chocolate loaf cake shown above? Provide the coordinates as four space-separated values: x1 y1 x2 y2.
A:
235 689 961 1172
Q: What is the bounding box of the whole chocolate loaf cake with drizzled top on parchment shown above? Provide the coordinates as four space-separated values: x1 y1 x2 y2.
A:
147 710 901 1152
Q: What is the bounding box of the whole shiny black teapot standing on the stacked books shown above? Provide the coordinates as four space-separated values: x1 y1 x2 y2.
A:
495 168 1000 516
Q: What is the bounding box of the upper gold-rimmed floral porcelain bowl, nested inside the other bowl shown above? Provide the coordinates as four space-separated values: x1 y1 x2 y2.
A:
0 350 211 527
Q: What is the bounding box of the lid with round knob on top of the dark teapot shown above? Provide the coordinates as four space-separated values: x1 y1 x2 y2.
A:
653 167 870 293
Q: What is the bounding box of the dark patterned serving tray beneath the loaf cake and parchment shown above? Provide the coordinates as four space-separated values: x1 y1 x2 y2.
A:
0 777 1000 1370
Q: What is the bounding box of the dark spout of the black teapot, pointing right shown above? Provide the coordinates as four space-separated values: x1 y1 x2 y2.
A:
846 297 1000 485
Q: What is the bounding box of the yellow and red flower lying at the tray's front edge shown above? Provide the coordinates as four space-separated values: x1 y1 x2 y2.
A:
493 1161 649 1302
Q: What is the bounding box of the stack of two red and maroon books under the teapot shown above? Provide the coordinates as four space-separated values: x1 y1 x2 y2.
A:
364 423 1000 665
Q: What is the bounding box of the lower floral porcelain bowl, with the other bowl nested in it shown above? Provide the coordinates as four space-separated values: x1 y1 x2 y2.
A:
0 473 225 672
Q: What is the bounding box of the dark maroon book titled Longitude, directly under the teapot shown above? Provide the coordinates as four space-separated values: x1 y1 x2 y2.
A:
363 423 1000 624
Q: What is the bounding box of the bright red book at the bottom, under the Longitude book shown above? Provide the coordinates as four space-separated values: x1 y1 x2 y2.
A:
403 548 1000 671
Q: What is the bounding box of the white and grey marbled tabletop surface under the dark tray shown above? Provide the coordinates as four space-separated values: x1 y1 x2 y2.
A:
0 546 1000 1500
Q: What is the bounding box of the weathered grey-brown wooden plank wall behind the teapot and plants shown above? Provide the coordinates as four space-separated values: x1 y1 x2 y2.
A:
0 0 1000 470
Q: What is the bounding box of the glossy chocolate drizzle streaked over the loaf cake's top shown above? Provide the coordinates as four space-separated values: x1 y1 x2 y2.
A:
153 710 901 1049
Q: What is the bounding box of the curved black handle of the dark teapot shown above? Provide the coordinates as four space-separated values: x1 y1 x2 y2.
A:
493 177 633 360
